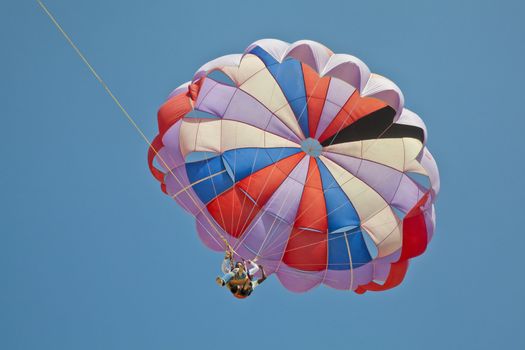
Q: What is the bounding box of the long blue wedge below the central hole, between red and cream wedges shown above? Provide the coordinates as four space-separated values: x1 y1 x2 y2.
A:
315 158 361 233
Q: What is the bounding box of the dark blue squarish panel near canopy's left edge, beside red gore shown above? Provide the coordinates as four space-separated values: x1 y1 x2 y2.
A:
186 156 233 204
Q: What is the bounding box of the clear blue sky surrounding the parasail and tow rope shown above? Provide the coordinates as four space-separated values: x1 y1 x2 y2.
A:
0 0 525 350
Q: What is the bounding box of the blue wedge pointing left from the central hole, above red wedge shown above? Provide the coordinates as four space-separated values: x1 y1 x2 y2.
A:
222 147 301 182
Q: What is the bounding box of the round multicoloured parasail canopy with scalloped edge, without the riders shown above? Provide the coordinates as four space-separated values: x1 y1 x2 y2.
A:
148 39 439 293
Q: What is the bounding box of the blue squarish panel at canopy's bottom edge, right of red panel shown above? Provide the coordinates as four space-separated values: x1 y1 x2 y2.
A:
328 229 372 270
